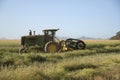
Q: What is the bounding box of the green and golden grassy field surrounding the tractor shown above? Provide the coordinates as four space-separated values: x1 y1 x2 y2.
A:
0 40 120 80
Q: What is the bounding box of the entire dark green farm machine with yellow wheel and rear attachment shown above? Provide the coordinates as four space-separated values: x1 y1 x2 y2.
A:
19 29 86 53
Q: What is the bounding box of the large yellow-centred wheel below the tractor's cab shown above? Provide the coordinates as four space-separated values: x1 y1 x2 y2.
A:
44 41 60 53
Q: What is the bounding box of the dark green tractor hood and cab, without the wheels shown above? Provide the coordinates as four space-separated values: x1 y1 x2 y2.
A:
21 29 58 47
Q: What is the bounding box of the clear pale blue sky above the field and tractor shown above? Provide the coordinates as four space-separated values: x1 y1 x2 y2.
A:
0 0 120 39
